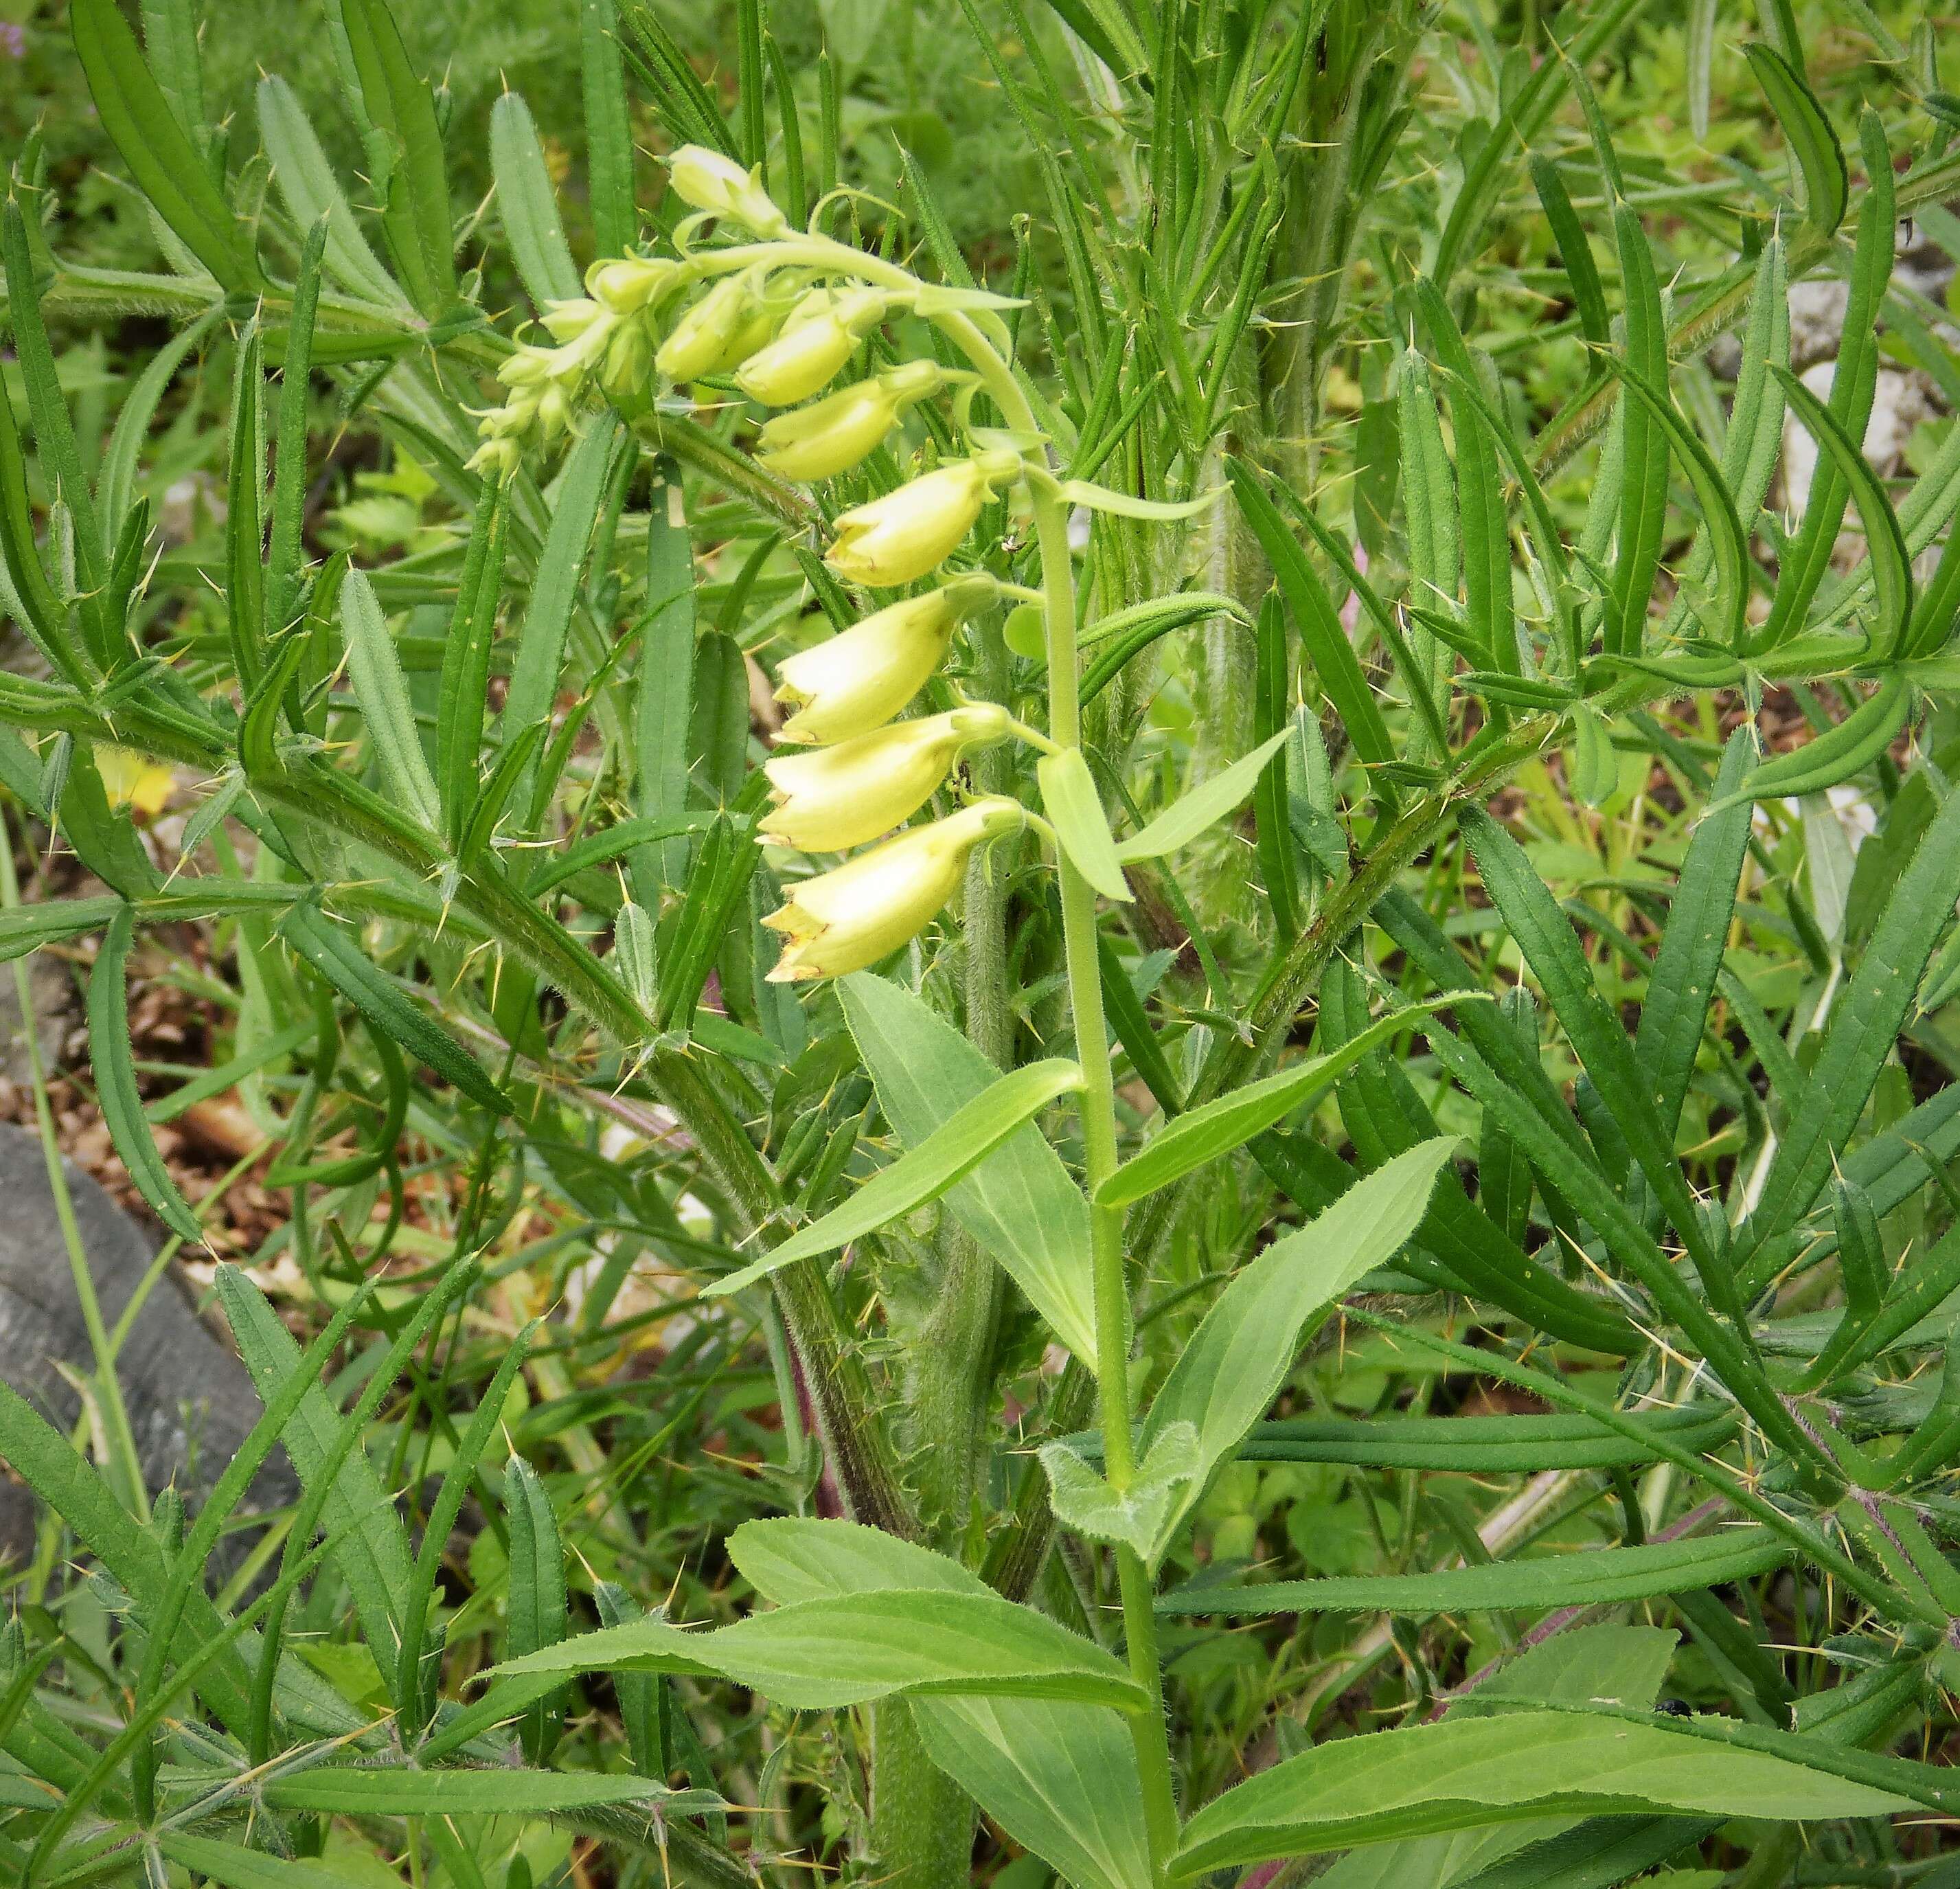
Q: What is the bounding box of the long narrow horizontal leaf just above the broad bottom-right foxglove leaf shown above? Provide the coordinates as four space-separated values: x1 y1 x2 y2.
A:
1156 1528 1790 1616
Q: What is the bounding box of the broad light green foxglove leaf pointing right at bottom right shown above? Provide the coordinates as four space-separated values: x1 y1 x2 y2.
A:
1172 1710 1909 1877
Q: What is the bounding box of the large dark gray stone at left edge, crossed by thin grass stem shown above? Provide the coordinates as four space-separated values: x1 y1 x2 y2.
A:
0 1124 294 1563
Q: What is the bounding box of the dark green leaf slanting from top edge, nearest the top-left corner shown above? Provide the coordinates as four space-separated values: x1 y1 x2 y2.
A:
69 0 257 288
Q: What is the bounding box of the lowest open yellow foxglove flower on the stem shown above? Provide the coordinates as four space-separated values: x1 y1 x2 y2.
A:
762 795 1027 984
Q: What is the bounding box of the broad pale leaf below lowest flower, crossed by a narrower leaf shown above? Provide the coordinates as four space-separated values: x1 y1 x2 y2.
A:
839 972 1095 1364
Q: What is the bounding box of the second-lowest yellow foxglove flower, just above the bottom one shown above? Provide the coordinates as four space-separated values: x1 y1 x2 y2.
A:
762 701 1010 852
